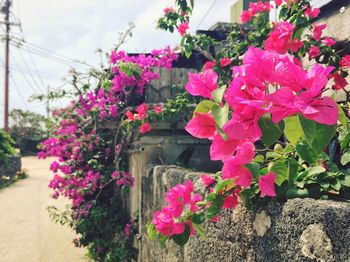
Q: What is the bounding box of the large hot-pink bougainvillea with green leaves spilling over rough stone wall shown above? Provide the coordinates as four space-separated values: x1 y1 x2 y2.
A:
152 0 350 248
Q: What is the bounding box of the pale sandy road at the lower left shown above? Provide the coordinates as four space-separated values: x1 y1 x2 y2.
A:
0 157 87 262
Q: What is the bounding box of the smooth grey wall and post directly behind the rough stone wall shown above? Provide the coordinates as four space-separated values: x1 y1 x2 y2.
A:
129 128 221 256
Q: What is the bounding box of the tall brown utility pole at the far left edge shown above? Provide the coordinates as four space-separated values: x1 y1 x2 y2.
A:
1 0 12 132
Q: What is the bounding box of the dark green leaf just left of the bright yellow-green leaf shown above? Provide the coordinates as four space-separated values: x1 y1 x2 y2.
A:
259 114 284 147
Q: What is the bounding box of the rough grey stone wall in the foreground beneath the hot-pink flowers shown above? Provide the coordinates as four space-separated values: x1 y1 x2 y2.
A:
139 166 350 262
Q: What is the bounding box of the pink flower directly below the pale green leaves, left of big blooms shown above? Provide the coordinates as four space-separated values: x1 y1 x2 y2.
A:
185 113 216 138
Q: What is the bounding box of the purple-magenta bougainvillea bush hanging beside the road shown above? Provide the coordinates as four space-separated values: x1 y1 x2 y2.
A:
38 47 177 260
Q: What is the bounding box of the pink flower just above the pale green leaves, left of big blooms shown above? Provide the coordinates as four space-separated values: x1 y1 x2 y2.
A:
185 69 218 99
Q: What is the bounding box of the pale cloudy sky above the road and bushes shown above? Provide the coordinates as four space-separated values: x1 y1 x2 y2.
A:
0 0 234 127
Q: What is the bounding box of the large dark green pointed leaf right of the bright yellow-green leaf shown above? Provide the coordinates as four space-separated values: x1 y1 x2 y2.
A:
299 115 337 153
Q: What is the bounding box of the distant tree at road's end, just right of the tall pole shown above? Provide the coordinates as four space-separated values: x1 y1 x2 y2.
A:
10 109 47 153
